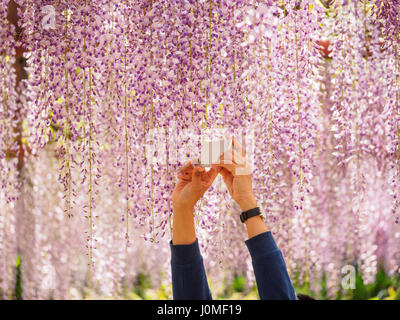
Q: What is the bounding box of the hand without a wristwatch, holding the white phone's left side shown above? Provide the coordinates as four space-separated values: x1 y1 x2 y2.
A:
172 161 220 210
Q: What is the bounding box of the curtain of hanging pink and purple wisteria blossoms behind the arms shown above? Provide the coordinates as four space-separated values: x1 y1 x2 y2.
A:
0 0 400 299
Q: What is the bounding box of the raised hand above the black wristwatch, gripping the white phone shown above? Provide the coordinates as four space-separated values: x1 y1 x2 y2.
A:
215 140 257 211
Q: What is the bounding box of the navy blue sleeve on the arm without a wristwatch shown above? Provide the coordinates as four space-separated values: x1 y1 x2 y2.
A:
170 239 212 300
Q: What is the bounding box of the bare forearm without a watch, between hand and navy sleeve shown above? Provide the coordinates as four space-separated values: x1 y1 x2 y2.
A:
172 205 196 245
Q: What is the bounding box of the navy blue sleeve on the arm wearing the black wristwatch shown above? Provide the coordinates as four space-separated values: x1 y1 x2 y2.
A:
245 232 297 300
